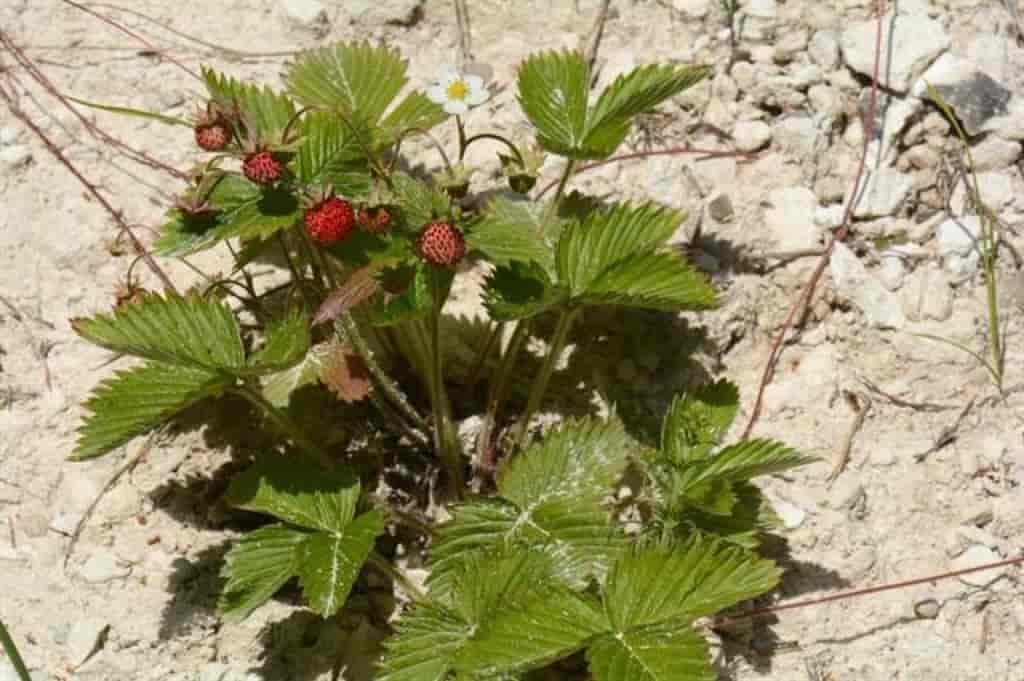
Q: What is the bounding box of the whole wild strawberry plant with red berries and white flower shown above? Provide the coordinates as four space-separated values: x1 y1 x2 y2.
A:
68 43 807 681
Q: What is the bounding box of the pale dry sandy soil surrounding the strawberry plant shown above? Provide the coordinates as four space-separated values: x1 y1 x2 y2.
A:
0 0 1024 681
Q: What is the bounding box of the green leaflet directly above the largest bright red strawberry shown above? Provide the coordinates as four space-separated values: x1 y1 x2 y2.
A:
292 112 371 191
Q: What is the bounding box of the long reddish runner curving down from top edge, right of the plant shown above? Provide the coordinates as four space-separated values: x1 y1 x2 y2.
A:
742 0 886 438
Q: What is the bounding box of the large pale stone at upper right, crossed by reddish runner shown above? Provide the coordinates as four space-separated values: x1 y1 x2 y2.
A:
840 12 950 92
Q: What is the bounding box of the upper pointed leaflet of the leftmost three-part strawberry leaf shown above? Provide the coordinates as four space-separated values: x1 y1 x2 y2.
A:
72 294 245 372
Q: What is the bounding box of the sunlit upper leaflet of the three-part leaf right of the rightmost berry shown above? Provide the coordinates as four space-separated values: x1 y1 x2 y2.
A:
558 203 684 295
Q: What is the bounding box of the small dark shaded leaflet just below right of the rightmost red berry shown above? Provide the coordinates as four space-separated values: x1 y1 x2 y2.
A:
483 262 568 322
